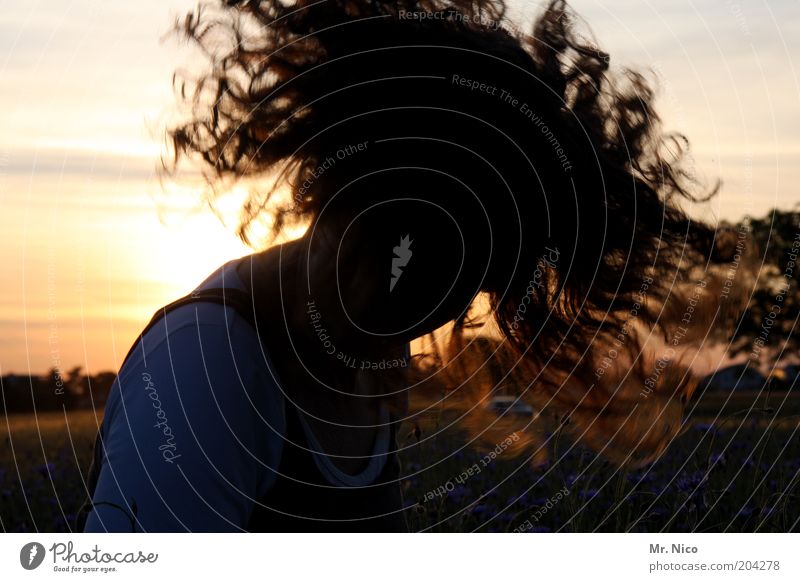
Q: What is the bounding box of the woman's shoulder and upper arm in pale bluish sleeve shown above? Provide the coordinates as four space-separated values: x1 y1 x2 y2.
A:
91 258 286 531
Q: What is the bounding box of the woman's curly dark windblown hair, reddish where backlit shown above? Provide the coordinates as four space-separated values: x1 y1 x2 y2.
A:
167 0 744 462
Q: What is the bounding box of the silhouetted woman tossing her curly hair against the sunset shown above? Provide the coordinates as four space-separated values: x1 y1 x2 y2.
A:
81 0 732 531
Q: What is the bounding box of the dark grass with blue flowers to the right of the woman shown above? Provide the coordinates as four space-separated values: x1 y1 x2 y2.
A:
404 393 800 532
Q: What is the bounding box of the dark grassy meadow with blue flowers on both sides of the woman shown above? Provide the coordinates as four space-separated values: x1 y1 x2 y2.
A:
0 395 800 532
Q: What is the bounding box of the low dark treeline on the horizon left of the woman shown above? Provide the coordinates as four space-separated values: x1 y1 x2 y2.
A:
0 366 117 414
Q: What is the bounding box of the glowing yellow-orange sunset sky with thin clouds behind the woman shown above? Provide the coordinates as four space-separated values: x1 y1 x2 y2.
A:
0 0 800 374
